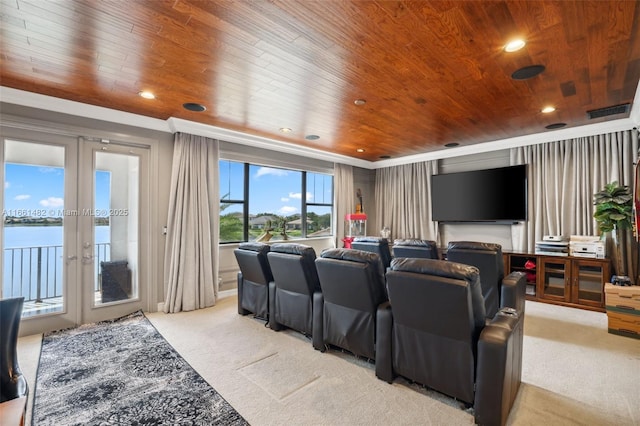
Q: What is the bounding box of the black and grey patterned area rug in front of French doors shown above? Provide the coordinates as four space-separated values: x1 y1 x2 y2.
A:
32 312 248 426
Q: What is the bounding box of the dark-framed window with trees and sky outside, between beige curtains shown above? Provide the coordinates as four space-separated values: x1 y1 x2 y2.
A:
220 160 333 243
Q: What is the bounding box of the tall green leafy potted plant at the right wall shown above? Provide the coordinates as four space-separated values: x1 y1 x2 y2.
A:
593 181 633 276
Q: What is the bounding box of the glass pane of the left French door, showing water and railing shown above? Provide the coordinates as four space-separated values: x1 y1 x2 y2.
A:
2 141 65 317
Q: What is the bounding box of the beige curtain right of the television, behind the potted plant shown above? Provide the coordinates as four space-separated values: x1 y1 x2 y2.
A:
510 130 638 277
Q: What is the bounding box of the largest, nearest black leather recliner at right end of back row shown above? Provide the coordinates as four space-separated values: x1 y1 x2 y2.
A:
376 258 523 425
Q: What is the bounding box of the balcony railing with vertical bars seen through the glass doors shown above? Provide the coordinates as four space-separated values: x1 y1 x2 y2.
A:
2 243 111 302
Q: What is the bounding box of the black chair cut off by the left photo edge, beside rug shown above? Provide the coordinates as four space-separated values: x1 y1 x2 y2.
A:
0 297 29 419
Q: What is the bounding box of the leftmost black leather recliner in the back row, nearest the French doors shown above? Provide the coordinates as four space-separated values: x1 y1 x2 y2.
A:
233 242 273 320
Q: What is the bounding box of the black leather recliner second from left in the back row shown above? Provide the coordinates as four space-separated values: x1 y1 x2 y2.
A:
267 243 321 336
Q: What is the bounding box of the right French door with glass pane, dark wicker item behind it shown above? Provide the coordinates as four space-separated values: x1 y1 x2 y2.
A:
81 141 148 322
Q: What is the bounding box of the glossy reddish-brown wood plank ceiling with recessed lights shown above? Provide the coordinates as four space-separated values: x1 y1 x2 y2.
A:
0 0 640 161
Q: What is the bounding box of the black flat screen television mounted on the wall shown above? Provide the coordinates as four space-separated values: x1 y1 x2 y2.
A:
431 165 527 223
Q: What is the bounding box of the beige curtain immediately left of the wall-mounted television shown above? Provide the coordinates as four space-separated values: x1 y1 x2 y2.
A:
375 161 438 241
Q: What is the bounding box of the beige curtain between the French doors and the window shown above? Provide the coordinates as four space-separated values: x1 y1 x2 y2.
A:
164 133 220 313
